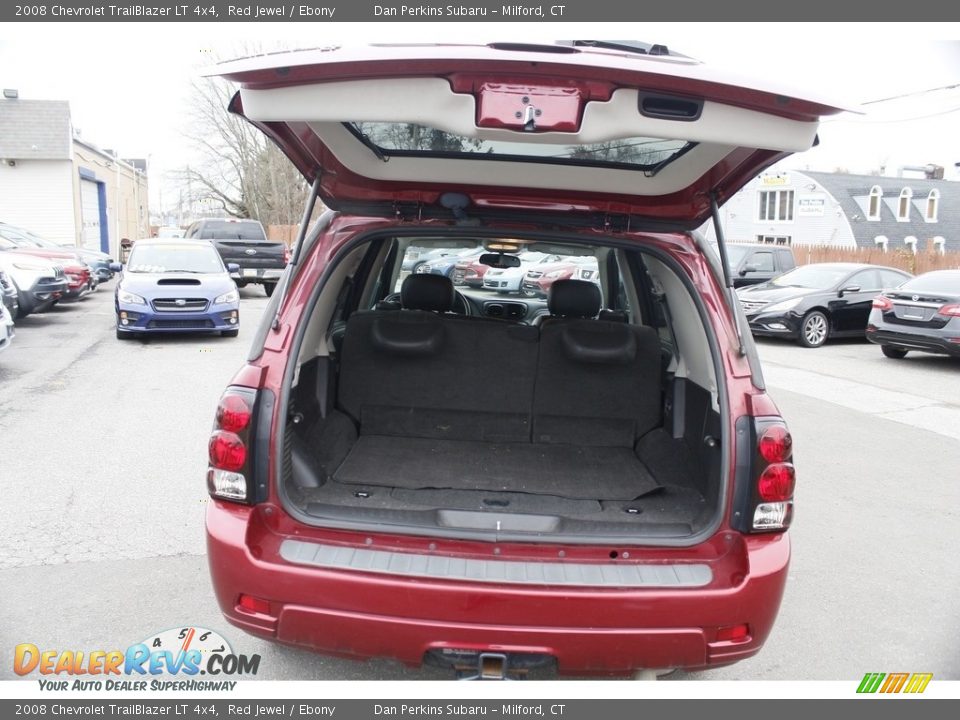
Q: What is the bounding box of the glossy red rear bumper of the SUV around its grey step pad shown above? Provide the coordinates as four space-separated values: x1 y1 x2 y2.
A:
207 500 790 675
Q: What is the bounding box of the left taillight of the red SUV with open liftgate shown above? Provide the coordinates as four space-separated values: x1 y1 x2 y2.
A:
207 387 257 503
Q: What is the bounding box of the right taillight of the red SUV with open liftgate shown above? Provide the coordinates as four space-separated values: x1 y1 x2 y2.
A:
731 417 796 532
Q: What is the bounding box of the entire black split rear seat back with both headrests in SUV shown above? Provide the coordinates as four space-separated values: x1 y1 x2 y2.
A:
338 275 661 447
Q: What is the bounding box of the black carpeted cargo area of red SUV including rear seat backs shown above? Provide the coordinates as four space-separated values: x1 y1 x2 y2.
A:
284 233 721 539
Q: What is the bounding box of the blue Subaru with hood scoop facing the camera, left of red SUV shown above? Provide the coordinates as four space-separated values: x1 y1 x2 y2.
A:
114 238 240 340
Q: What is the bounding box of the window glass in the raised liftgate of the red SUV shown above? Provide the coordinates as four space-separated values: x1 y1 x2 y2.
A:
346 122 693 170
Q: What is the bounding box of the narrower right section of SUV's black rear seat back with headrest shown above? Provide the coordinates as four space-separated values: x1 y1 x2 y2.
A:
532 280 661 447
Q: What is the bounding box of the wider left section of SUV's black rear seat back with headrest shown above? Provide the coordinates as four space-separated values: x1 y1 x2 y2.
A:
338 275 538 442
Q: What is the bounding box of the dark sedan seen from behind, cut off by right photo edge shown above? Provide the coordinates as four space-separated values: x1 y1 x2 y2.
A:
867 270 960 360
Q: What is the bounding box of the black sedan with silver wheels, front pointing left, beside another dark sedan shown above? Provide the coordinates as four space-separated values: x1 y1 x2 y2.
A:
737 263 912 348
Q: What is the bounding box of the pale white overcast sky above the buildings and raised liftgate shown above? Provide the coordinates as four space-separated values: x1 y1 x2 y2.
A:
0 22 960 209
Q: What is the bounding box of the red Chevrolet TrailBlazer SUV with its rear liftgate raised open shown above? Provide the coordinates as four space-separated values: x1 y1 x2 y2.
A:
207 44 839 676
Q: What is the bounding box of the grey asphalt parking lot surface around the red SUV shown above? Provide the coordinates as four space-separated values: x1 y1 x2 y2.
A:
0 283 960 680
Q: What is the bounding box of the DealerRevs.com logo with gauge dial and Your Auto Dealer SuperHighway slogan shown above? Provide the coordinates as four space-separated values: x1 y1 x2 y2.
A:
13 627 260 691
